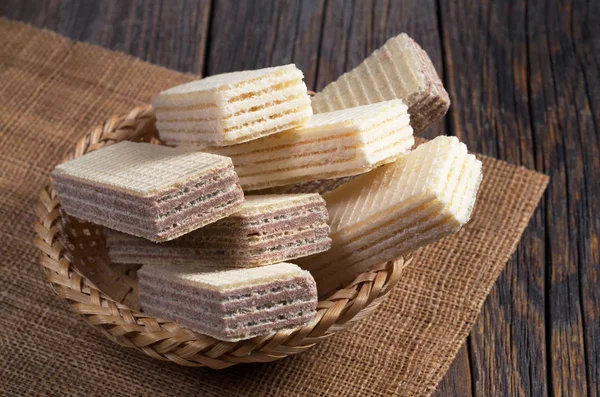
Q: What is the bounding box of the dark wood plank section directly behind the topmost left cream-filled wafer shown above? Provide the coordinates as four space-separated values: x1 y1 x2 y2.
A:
207 0 324 88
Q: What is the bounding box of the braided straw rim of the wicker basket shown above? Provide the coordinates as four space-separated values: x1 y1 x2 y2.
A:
34 105 412 369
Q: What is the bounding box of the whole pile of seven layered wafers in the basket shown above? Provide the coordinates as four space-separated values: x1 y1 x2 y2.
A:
52 35 482 342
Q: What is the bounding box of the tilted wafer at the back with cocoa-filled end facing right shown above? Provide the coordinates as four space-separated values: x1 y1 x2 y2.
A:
312 33 450 134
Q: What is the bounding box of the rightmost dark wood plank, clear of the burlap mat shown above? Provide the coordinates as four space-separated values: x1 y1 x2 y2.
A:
528 0 600 396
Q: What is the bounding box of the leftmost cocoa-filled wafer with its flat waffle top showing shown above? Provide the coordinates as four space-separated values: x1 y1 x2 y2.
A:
52 141 244 242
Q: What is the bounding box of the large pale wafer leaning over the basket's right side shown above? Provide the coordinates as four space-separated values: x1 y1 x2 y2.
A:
298 137 482 295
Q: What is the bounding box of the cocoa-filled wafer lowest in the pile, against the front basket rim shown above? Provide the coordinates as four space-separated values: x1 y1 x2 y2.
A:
138 263 317 341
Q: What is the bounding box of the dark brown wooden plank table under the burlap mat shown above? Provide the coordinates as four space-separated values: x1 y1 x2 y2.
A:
0 0 600 396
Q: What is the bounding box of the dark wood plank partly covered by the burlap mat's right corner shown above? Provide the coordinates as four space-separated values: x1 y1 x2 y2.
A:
441 1 547 396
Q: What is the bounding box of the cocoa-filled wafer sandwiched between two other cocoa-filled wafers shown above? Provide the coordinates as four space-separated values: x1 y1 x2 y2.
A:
104 194 331 269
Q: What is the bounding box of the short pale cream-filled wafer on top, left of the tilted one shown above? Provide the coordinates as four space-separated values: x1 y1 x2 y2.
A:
152 64 312 146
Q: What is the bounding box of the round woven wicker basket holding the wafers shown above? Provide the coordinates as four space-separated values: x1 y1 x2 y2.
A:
35 106 411 369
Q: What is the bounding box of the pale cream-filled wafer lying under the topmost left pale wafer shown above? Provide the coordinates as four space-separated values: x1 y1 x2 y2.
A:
197 100 414 190
